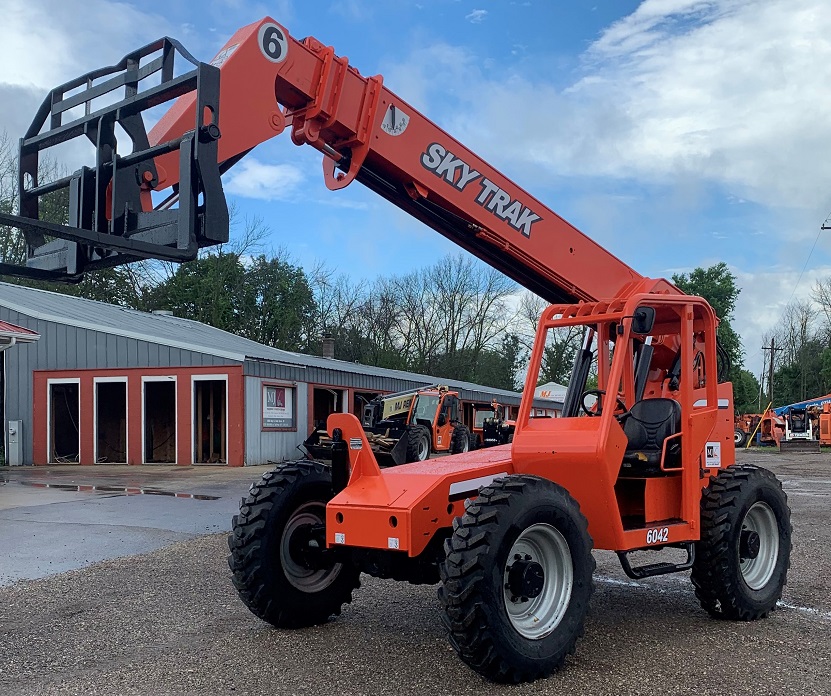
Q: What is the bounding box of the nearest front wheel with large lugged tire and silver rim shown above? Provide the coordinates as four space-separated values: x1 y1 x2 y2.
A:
439 476 595 682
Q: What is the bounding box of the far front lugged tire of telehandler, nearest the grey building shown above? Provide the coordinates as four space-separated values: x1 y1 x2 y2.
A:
228 460 360 628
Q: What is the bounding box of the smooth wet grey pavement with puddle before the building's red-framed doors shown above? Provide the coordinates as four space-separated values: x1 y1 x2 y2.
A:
0 466 269 586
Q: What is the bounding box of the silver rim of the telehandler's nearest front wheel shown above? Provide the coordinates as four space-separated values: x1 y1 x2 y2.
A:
503 524 574 640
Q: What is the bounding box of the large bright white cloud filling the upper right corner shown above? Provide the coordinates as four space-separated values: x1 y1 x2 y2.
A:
569 0 831 205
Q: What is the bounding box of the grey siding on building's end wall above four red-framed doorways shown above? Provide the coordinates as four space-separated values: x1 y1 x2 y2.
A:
0 306 232 464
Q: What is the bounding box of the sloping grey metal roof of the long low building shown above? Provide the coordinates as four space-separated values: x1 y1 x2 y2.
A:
0 282 532 399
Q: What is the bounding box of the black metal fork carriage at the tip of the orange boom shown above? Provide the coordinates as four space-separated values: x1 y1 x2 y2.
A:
0 38 228 282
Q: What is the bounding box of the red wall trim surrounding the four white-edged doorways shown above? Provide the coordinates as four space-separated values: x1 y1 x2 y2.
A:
32 365 245 466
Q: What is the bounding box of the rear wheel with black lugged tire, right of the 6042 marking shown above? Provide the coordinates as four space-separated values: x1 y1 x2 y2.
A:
692 465 791 621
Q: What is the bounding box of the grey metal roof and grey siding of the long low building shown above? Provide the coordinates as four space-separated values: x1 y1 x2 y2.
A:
0 283 564 463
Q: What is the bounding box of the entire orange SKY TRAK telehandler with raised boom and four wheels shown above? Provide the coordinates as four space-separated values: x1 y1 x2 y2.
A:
0 18 791 682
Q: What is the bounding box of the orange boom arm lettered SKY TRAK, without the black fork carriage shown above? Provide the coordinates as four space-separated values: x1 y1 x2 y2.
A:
151 17 648 302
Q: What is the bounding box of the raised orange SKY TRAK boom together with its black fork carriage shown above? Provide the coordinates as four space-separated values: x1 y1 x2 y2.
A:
0 17 656 302
